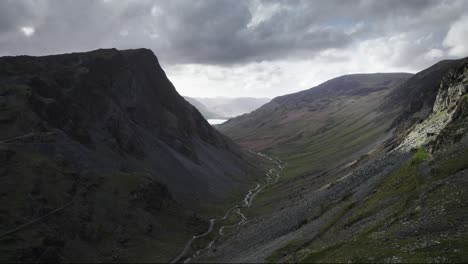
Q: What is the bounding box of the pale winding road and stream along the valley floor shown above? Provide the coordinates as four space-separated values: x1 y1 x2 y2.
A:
171 153 284 263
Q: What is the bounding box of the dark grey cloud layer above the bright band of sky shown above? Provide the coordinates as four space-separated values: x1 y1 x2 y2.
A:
0 0 468 65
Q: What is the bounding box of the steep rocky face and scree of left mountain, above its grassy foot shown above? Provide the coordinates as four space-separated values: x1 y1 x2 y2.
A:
0 49 258 201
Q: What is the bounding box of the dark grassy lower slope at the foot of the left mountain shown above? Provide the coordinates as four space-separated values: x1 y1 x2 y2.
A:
0 147 241 262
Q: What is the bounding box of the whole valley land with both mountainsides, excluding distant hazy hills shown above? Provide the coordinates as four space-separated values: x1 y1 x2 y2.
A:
0 49 468 263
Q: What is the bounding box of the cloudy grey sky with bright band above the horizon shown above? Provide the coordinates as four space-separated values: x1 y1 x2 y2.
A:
0 0 468 98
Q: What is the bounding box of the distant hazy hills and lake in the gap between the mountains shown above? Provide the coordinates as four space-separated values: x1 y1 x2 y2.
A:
192 97 270 119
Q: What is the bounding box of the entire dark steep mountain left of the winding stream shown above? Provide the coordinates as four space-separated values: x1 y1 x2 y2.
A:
0 49 259 262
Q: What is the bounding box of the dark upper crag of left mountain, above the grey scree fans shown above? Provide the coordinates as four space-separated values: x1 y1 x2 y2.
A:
2 50 221 156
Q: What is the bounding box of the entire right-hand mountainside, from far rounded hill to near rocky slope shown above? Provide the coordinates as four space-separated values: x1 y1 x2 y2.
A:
206 58 468 263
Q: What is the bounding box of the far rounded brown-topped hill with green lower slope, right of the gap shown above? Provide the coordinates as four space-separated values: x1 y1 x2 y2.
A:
219 73 411 174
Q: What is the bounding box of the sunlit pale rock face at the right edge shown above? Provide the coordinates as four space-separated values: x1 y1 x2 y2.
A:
397 61 468 151
